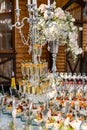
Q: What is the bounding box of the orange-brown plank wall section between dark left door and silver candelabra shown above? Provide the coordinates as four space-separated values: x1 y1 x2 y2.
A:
15 0 31 79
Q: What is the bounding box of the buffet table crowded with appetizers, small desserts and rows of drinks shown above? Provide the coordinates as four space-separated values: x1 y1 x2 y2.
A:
0 74 87 130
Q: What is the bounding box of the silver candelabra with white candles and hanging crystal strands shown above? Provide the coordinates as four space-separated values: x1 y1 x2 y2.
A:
12 0 50 53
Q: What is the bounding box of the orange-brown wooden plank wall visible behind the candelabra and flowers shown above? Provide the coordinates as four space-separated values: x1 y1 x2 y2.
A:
15 0 83 80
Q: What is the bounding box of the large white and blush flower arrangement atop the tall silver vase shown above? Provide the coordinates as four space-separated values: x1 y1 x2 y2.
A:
36 2 82 59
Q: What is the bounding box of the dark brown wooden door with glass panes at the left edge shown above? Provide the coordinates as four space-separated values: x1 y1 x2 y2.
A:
0 0 16 86
